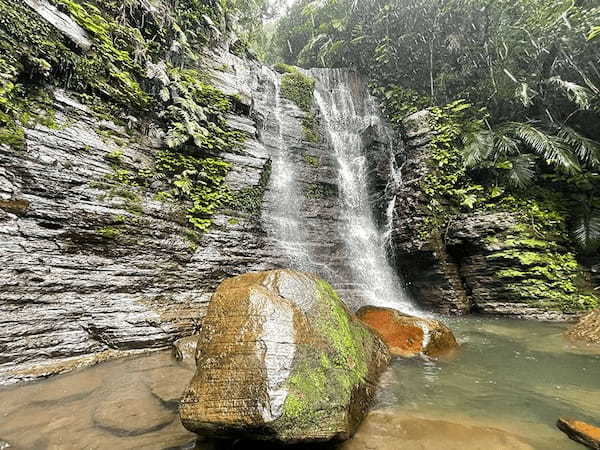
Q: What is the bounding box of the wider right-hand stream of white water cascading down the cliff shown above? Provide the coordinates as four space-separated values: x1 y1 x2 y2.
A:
312 69 416 313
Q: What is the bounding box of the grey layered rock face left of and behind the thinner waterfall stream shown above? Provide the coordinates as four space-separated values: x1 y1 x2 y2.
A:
0 6 398 383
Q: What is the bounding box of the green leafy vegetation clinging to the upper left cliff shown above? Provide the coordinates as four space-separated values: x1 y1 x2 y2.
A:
0 0 267 236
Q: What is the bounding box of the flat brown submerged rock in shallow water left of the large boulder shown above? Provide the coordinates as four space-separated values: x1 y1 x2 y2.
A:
93 384 175 436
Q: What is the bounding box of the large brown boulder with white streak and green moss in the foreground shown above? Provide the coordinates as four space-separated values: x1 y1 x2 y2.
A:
180 270 390 443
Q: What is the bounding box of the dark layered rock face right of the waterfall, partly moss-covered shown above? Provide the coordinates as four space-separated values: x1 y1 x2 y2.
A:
392 111 598 320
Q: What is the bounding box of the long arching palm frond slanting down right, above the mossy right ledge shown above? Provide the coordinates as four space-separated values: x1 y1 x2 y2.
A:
510 122 581 173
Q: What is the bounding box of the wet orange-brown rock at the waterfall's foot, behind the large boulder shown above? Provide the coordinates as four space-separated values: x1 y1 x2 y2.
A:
356 306 458 358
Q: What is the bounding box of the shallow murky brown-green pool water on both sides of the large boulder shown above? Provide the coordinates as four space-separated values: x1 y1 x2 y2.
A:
0 318 600 450
